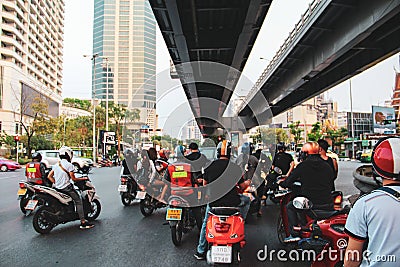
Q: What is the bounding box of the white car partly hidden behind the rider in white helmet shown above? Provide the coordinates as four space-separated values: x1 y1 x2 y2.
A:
36 150 93 173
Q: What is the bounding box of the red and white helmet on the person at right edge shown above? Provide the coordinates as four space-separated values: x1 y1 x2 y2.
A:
371 137 400 180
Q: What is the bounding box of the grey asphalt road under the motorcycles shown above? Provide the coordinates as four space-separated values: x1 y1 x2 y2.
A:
0 162 360 267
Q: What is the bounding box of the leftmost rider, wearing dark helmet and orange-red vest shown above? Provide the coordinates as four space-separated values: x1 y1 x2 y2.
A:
25 152 51 186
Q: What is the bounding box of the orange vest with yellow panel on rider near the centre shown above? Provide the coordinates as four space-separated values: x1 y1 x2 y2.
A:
168 163 193 195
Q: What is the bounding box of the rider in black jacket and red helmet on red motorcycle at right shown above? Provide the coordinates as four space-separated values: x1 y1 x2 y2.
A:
280 142 334 242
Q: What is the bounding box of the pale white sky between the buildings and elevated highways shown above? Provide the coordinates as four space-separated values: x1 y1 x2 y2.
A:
63 0 400 133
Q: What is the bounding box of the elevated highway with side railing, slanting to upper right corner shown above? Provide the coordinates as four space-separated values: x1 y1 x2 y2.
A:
238 0 400 129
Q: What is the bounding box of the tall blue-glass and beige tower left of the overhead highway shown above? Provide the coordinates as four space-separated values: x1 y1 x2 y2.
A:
93 0 156 128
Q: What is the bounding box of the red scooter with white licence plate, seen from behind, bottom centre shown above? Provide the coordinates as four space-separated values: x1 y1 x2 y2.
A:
206 207 246 264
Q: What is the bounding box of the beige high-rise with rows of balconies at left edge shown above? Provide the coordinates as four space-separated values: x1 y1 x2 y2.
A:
0 0 65 135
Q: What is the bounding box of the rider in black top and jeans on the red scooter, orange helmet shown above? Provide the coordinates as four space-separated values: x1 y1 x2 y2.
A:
194 140 250 260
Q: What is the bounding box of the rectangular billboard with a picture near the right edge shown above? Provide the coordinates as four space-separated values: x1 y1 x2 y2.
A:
372 106 396 134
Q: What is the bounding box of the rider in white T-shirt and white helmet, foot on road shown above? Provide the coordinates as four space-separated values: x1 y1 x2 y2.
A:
48 146 94 229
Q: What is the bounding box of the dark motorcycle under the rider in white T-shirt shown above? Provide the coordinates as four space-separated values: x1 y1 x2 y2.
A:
30 180 101 234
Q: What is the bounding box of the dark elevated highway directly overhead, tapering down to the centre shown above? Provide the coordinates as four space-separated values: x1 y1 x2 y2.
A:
149 0 272 135
